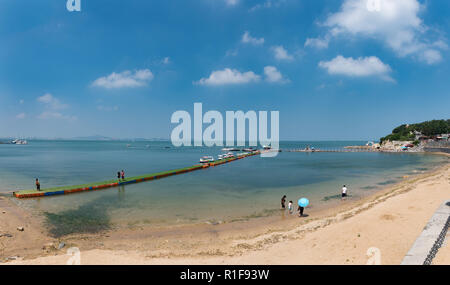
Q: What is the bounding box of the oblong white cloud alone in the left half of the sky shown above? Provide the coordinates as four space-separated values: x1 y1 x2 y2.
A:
92 69 154 89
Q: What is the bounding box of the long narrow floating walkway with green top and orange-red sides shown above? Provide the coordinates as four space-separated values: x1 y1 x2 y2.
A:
13 151 260 198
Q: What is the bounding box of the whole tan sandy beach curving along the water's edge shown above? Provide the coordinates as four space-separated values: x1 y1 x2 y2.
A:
0 153 450 264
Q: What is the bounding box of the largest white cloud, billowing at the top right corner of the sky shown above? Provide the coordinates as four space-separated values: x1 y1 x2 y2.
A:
314 0 446 64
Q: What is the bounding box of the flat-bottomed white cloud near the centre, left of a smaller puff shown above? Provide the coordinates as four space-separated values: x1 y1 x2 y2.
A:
194 68 260 86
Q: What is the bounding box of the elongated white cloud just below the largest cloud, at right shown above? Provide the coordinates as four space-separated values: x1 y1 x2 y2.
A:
319 55 394 82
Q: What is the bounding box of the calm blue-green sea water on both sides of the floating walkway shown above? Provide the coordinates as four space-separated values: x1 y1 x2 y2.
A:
0 141 448 235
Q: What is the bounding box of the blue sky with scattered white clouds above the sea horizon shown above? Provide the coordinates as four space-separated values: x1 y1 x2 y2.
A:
0 0 450 140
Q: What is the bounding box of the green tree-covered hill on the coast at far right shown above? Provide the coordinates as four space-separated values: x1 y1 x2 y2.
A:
380 120 450 143
